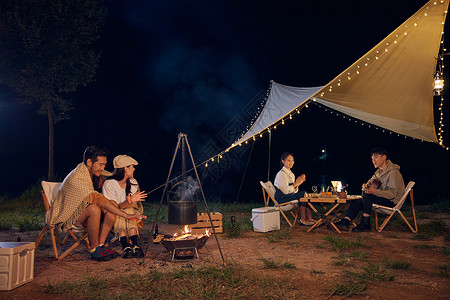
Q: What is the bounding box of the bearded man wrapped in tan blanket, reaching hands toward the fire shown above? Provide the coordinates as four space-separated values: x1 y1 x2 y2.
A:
49 146 146 261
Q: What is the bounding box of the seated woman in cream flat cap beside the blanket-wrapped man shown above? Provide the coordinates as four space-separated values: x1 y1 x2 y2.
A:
102 155 147 258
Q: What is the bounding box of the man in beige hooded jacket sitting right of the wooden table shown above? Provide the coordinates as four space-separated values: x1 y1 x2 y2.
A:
335 147 405 232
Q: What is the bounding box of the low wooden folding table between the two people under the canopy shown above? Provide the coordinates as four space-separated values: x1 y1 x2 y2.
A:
300 195 362 233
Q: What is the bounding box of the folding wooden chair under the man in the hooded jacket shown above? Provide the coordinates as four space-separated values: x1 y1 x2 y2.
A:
372 181 418 233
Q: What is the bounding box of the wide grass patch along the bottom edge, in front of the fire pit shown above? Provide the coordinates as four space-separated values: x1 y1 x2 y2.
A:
46 264 302 299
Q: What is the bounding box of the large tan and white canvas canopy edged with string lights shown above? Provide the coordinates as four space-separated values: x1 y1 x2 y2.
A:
230 0 449 148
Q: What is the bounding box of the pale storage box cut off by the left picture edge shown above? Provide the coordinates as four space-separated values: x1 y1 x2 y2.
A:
0 242 34 290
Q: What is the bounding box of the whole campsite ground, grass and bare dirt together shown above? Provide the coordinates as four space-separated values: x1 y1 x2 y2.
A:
0 186 450 299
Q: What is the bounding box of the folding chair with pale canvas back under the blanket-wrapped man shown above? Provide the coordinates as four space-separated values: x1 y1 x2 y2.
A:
35 181 89 260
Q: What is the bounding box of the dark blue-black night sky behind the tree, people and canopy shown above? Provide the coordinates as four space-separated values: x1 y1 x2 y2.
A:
0 0 450 203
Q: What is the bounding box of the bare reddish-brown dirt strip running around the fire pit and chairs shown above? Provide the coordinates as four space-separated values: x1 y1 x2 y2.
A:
0 215 450 299
